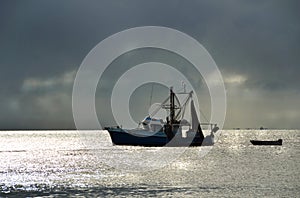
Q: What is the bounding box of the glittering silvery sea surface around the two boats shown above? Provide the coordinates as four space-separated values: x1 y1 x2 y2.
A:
0 130 300 197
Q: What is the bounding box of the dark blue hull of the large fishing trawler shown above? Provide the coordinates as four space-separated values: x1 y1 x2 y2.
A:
106 128 212 147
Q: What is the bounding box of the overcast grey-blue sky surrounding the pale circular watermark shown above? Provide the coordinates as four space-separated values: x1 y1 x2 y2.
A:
0 0 300 130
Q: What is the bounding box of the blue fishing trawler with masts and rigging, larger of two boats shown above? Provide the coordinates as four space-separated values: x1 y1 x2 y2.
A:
104 87 219 147
